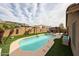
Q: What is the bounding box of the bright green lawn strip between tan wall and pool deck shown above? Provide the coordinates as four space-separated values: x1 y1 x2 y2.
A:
0 33 45 56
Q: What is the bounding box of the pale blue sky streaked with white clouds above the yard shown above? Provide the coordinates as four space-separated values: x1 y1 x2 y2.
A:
0 3 70 26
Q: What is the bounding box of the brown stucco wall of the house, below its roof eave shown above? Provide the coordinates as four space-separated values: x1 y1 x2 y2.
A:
67 12 79 55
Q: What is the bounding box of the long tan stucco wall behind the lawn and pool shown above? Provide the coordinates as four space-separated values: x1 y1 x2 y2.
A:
3 27 47 37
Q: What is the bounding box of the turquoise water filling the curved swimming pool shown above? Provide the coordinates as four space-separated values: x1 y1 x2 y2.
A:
19 35 55 51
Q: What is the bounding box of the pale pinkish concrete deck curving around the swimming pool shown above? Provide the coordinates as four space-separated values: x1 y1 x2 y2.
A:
9 34 61 56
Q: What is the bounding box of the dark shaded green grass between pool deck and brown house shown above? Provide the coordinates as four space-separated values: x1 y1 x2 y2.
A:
46 39 73 56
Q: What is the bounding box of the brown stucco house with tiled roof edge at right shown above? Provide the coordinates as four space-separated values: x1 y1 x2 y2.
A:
66 3 79 55
